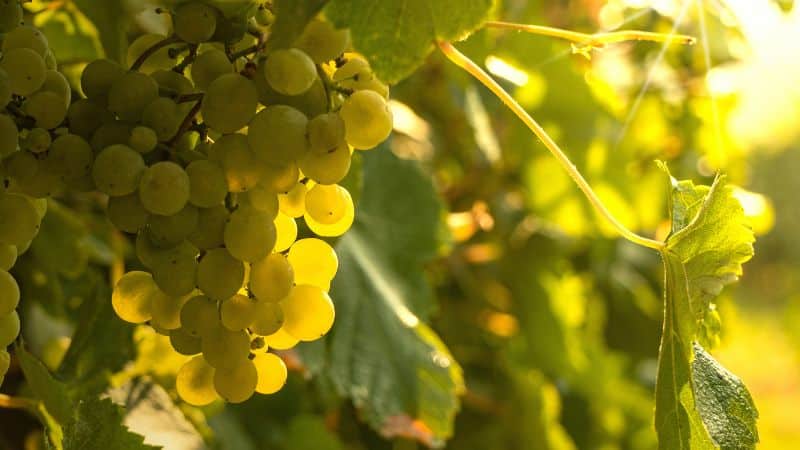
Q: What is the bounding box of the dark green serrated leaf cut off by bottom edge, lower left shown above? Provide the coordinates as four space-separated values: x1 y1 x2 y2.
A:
63 397 160 450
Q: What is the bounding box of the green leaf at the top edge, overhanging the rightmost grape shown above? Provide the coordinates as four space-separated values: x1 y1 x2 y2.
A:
325 0 494 83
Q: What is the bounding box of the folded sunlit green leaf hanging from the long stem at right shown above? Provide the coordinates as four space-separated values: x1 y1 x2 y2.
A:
656 168 758 450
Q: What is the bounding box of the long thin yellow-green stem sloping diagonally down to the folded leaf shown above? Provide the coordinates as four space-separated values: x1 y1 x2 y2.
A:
437 41 665 251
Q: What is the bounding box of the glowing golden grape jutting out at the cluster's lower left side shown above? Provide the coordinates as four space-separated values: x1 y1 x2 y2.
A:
111 271 158 323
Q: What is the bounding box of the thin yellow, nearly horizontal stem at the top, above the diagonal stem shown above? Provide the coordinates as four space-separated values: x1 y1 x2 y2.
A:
484 21 697 57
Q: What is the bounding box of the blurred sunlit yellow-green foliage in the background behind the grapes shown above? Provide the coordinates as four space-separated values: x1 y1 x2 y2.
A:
0 0 800 450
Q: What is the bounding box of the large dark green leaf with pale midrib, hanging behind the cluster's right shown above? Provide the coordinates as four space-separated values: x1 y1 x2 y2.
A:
312 146 463 445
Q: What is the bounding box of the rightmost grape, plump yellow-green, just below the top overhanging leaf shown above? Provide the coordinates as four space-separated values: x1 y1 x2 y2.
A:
339 91 393 150
